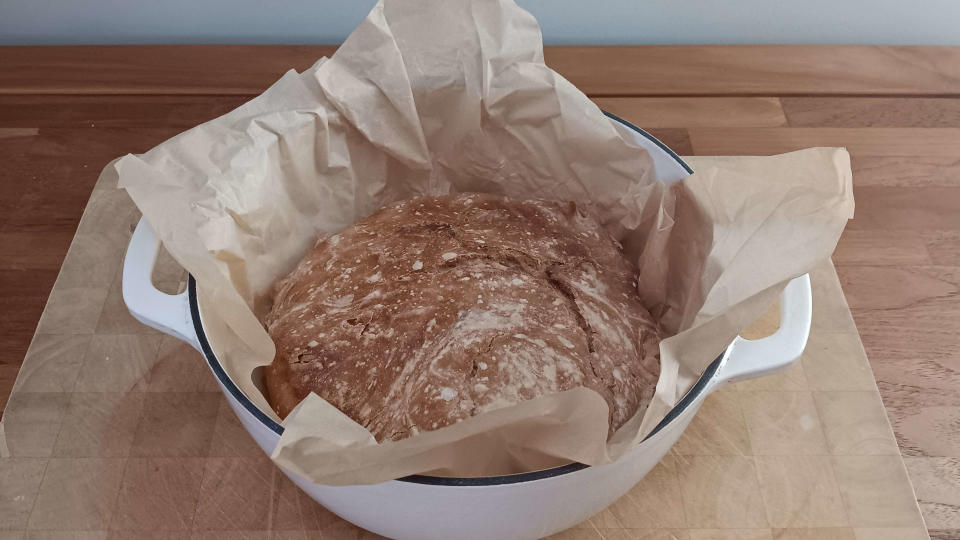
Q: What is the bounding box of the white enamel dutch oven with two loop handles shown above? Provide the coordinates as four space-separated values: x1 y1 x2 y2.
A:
123 114 812 539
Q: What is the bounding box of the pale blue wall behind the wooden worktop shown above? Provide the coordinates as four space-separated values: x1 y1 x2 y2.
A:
0 0 960 45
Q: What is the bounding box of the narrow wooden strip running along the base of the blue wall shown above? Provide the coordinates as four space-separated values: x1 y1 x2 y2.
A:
0 45 960 97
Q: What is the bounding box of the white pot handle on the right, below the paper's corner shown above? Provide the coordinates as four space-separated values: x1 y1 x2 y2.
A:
717 274 813 383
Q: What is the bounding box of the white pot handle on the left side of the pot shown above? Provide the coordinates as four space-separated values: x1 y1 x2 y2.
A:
122 217 201 351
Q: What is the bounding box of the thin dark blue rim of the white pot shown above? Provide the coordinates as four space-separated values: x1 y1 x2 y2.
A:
187 111 723 486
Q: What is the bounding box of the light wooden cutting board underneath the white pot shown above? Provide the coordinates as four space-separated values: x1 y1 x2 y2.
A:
0 172 928 540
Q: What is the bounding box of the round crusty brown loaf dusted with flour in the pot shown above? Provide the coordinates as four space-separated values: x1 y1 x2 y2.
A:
264 194 660 441
